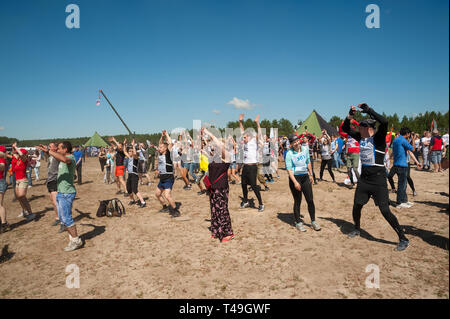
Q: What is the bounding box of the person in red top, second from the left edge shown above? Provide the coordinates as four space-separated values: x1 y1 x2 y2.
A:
11 143 36 219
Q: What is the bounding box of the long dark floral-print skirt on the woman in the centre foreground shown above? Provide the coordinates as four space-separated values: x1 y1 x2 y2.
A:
209 189 233 240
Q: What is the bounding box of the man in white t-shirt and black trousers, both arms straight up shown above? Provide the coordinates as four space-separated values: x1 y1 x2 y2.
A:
239 114 264 212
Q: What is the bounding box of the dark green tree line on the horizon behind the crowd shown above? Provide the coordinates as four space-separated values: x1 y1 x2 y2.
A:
0 111 449 147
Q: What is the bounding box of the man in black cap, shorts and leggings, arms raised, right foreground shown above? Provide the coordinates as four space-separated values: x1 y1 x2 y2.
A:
342 103 409 251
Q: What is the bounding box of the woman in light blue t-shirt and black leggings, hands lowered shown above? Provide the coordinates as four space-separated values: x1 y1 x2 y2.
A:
285 134 320 232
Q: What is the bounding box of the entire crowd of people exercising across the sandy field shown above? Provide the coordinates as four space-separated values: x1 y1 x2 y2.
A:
0 103 449 251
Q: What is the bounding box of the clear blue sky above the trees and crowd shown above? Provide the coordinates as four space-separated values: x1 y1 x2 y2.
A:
0 0 449 139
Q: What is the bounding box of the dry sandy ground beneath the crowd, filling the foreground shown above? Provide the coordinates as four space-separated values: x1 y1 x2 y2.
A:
0 159 449 299
